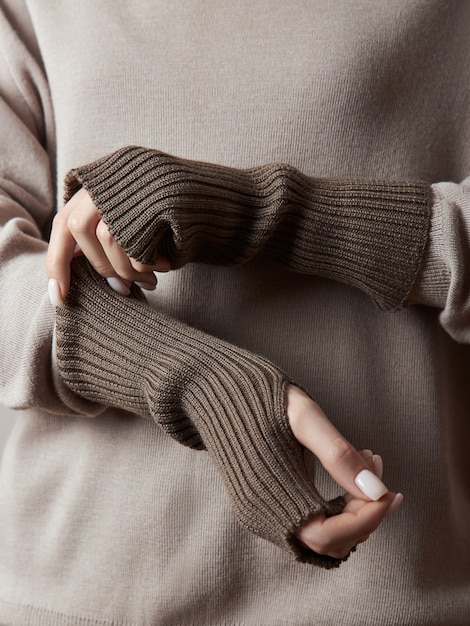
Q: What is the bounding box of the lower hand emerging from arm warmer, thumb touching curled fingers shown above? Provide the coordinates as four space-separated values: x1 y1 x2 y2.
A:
287 386 403 559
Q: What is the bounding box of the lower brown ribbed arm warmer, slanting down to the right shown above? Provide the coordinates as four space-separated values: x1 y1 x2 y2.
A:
56 258 343 567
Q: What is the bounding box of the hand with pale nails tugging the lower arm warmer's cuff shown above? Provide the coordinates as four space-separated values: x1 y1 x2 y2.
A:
46 189 170 305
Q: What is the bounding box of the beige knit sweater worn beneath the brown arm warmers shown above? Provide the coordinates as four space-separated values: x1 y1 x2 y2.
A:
0 0 470 626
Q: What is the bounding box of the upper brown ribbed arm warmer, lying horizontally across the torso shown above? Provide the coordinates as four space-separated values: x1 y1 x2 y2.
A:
66 146 432 310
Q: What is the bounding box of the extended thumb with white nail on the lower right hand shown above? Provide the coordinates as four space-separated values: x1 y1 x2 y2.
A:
287 385 388 500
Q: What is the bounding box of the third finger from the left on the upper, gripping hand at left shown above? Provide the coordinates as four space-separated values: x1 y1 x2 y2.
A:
96 220 157 289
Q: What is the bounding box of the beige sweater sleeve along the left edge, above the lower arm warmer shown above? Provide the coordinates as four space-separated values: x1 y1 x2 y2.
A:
0 6 103 413
